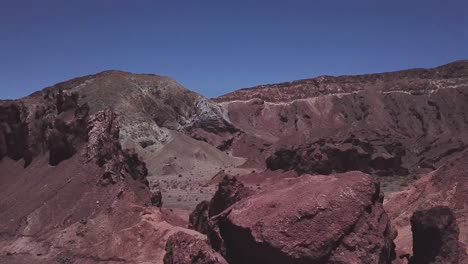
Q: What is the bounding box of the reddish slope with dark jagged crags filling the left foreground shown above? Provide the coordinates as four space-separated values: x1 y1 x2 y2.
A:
0 96 197 264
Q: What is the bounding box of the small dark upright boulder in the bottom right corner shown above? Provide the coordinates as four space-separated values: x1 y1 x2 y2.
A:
410 206 468 264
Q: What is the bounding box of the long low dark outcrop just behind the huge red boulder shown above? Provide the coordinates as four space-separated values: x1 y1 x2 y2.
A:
266 137 408 176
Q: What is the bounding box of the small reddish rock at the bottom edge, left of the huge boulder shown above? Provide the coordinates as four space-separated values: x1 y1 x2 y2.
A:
164 232 227 264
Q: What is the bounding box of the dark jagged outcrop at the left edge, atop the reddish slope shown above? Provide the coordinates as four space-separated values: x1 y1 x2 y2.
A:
0 90 89 167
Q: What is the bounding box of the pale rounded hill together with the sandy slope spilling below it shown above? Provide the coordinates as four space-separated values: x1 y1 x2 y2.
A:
13 71 244 208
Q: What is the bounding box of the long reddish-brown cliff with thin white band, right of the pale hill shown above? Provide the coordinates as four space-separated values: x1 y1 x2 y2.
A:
206 61 468 179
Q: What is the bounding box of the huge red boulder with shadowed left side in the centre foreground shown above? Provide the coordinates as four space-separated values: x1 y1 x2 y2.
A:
209 172 395 264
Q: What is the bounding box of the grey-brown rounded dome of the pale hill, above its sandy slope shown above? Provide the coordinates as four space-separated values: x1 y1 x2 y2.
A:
30 71 226 151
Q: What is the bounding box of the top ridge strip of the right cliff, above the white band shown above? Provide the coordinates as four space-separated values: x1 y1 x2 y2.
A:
214 61 468 103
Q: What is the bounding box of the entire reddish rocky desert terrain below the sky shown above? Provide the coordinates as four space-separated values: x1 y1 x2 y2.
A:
0 61 468 264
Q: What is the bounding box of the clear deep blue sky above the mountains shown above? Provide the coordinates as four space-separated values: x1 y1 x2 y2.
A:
0 0 468 98
